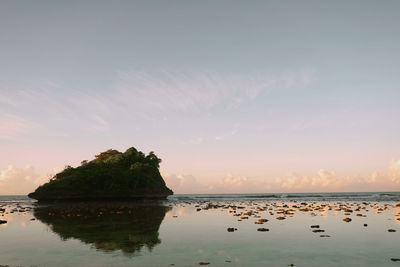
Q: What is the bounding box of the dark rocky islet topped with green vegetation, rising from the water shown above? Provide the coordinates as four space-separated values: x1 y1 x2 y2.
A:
28 147 173 201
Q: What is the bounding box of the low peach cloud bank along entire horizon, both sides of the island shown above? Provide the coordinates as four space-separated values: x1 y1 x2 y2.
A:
0 159 400 195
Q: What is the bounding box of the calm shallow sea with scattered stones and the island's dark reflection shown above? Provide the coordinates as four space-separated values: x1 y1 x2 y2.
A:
0 192 400 266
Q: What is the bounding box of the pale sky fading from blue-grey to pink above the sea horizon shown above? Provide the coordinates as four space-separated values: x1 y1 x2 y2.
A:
0 0 400 194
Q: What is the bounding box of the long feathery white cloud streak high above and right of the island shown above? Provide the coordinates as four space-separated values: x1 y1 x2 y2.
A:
115 70 315 112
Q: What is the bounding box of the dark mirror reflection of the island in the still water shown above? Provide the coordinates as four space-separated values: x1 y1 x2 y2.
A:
34 202 170 255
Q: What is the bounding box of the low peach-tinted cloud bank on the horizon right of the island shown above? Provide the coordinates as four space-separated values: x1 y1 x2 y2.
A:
163 159 400 194
